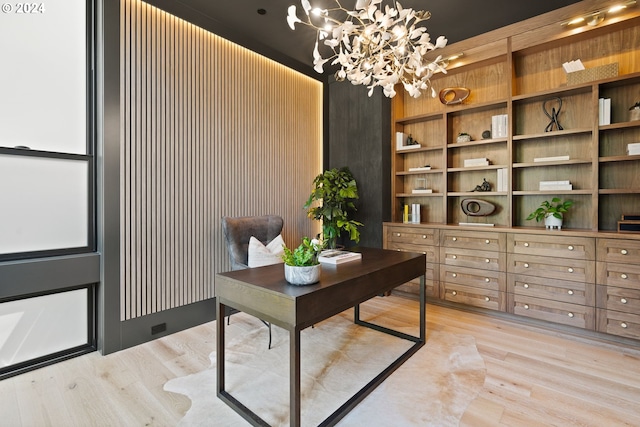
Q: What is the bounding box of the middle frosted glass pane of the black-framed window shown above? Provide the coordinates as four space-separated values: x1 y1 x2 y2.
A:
0 154 89 254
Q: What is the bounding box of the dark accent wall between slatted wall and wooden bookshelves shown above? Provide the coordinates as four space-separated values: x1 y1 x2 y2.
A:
325 81 391 248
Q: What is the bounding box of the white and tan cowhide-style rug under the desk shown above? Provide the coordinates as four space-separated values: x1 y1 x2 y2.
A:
164 311 486 427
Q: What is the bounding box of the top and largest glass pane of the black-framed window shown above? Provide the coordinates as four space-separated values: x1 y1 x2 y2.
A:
0 0 87 154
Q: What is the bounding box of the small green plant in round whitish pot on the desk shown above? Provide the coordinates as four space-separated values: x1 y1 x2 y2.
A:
282 237 324 285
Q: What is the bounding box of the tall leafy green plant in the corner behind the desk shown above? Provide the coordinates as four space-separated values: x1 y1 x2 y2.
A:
304 167 362 249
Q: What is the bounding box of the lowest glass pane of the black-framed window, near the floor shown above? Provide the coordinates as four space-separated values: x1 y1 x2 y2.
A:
0 289 89 368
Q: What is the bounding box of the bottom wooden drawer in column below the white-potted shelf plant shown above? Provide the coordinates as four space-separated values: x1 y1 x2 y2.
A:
507 293 595 329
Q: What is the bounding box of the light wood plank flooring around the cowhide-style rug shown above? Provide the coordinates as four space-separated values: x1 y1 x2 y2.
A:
0 296 640 427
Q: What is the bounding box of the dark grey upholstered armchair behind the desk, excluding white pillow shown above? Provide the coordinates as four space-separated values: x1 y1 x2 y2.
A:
222 215 284 348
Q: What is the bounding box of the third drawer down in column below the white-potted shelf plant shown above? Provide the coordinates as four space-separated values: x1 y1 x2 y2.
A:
507 274 596 306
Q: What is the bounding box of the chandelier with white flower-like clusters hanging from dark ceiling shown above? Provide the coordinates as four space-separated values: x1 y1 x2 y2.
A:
287 0 447 98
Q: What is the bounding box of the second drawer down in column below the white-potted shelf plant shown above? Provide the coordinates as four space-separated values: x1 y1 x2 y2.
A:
507 254 596 283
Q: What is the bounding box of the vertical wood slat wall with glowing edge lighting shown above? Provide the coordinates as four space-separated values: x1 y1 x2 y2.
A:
120 0 322 320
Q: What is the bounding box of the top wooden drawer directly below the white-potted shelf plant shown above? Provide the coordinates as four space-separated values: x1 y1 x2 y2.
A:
507 234 596 260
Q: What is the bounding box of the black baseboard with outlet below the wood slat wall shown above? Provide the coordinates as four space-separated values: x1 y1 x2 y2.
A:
120 298 216 350
